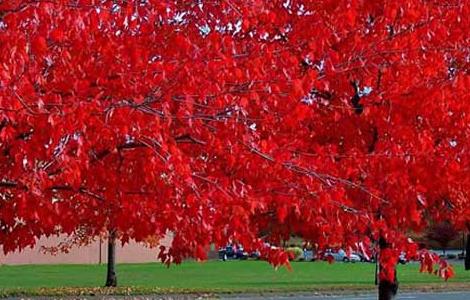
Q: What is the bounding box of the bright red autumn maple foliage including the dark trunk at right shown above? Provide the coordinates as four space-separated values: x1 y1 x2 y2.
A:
0 0 470 299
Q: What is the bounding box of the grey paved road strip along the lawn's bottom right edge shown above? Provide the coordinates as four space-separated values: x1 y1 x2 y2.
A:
222 292 470 300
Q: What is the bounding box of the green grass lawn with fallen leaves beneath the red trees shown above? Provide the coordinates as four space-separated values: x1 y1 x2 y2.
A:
0 261 470 296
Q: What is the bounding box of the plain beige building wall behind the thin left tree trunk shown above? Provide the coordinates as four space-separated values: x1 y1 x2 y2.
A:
0 237 171 265
